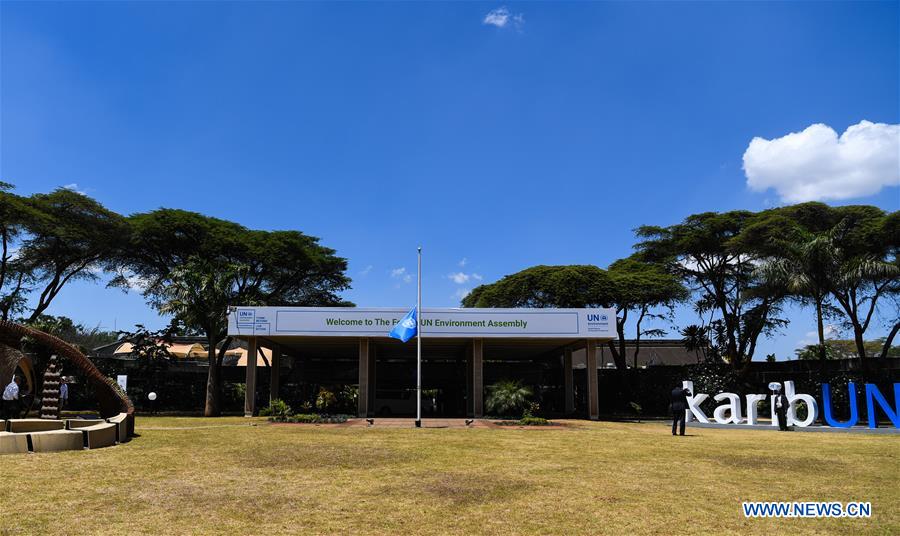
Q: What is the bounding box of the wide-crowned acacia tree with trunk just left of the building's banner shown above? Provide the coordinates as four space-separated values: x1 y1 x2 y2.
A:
115 209 352 416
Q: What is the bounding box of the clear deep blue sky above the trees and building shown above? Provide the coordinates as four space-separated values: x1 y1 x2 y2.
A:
0 2 900 357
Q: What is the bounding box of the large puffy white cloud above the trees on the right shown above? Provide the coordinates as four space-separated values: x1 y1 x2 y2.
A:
744 121 900 203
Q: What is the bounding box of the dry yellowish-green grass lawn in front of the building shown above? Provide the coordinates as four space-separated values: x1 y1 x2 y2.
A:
0 417 900 535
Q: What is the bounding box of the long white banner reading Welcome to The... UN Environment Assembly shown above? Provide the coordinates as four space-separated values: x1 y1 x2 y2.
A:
228 307 615 339
